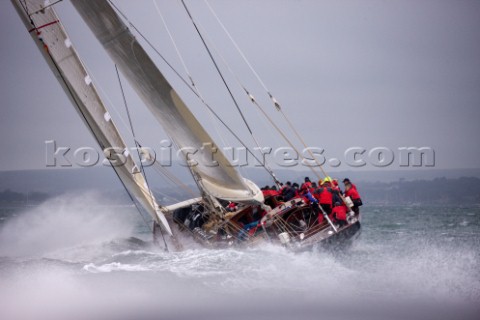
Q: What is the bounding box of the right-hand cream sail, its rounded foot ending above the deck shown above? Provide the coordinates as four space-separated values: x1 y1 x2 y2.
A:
72 0 263 201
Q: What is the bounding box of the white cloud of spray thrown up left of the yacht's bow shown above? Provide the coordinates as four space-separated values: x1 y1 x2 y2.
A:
0 193 137 256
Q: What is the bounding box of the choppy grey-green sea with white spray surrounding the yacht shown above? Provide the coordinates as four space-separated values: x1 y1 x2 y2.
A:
0 194 480 320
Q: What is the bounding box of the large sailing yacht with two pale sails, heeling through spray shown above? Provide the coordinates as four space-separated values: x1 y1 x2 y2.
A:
12 0 360 250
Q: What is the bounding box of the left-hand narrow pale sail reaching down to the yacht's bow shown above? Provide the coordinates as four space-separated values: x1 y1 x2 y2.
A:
12 0 172 235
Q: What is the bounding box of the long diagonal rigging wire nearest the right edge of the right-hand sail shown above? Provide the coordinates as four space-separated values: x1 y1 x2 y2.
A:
107 0 277 181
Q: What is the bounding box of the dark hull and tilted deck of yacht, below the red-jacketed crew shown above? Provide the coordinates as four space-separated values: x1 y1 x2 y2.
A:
167 201 360 251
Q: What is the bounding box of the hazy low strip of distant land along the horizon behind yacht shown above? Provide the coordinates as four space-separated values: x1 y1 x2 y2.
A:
0 167 480 204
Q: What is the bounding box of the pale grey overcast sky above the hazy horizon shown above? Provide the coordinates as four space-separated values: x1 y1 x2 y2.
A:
0 0 480 174
